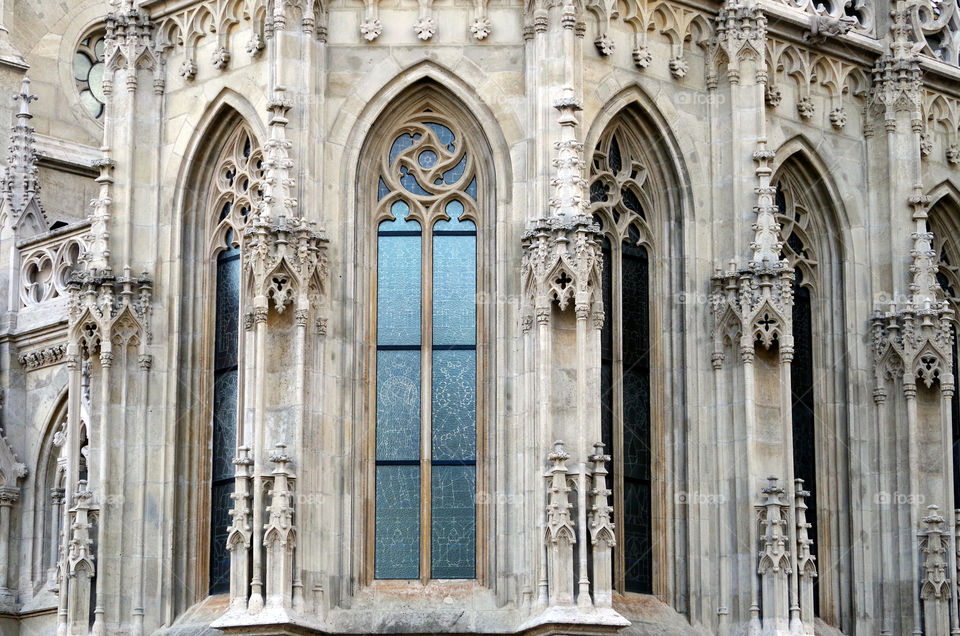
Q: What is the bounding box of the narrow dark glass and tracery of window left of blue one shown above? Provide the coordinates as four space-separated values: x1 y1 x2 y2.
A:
209 126 263 594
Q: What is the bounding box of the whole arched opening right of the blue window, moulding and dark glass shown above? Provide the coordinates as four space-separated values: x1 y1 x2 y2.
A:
587 105 682 595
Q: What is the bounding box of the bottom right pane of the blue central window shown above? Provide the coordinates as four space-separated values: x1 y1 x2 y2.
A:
430 466 477 579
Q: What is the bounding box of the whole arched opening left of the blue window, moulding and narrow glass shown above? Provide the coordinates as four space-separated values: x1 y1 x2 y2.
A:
173 104 262 609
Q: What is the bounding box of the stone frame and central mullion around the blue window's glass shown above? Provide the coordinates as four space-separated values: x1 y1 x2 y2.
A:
356 97 495 590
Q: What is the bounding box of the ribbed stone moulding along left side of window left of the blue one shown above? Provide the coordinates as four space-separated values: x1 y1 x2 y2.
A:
171 105 264 611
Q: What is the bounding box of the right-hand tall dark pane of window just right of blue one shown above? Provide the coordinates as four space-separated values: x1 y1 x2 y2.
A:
620 237 653 593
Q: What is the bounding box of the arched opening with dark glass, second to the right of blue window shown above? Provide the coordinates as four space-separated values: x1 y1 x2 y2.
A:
771 150 850 626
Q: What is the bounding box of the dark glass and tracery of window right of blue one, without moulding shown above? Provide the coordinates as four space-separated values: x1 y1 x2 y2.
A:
589 125 654 593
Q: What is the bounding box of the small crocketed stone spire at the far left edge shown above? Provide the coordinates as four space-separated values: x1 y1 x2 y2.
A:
0 77 47 233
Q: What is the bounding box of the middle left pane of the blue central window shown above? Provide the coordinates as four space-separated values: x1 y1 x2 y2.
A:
377 350 420 461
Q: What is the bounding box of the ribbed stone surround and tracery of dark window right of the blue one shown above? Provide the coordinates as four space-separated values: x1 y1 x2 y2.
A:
583 98 687 596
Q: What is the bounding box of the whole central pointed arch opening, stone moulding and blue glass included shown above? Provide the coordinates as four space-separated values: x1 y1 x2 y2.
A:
356 80 496 583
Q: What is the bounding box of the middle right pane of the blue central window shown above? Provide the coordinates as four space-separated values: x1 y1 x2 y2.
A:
433 350 477 461
